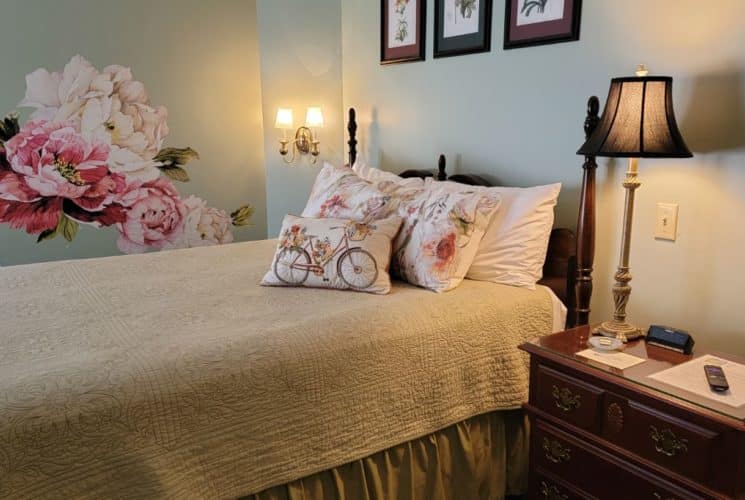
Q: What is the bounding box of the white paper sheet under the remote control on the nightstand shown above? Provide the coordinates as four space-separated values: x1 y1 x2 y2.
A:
649 355 745 408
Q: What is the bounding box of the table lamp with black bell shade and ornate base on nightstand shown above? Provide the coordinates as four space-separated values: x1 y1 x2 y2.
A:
577 65 693 342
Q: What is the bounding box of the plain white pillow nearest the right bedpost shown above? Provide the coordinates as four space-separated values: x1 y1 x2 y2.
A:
433 181 561 289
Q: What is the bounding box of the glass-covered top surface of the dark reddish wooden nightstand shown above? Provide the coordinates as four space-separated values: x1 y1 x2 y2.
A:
521 326 745 427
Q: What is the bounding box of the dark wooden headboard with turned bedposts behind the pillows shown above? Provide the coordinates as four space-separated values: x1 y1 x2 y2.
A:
347 103 600 328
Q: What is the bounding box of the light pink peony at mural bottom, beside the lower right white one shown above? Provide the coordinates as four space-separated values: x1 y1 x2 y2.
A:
117 178 189 253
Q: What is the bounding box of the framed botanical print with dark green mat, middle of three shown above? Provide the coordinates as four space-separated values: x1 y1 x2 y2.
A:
435 0 492 57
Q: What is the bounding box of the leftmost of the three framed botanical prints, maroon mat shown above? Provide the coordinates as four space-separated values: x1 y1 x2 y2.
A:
380 0 427 64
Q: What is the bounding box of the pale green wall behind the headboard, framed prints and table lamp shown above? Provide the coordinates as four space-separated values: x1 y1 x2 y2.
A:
342 0 745 354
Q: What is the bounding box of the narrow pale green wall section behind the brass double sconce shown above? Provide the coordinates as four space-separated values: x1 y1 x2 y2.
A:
257 0 344 238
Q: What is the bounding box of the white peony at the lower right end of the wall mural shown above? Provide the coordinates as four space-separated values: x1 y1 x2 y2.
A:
166 196 233 249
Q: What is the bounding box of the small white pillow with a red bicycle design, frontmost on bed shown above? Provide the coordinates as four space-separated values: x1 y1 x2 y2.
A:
261 215 401 294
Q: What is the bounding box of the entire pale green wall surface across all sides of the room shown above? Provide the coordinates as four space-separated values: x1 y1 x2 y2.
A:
7 0 745 354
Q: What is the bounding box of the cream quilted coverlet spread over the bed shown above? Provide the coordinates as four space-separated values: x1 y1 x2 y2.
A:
0 241 552 498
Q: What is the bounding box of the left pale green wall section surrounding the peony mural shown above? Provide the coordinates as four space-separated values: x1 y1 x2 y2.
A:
0 0 266 265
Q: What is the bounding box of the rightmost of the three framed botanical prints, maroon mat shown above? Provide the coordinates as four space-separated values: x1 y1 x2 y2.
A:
504 0 582 49
